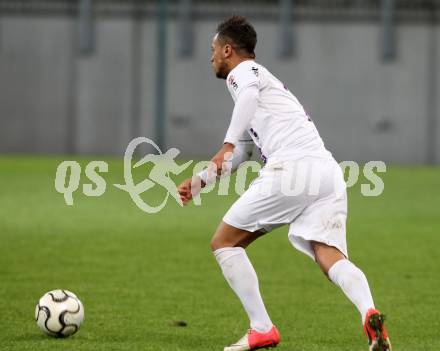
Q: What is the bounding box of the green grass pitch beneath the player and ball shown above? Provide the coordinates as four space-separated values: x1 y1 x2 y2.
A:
0 156 440 351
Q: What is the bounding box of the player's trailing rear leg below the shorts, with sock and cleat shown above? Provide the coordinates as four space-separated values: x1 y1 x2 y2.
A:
311 241 391 351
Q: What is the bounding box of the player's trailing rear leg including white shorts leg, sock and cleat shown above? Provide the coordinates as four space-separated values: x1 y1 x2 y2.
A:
289 161 391 351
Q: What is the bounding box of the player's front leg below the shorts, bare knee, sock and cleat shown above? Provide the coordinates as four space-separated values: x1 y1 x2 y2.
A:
211 221 280 351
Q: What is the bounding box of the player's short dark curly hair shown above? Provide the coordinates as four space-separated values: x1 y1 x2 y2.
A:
217 16 257 57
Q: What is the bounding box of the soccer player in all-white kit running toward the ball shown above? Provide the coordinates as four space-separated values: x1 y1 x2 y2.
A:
178 16 391 351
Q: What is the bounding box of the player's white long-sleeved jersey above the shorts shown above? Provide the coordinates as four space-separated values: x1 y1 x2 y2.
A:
225 60 331 164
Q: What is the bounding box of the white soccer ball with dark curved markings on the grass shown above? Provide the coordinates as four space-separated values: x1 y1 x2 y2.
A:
35 289 84 337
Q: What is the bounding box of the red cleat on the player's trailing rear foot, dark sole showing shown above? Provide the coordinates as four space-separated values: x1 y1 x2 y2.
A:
364 308 391 351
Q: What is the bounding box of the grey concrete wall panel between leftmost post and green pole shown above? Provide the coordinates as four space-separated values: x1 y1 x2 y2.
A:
75 19 132 154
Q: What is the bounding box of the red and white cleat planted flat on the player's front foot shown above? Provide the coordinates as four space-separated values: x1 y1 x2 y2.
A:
224 326 281 351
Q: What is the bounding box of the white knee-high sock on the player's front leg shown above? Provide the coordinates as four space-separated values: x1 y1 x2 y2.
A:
214 247 272 333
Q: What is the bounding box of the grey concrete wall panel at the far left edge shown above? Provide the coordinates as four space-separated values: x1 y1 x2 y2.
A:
0 18 73 153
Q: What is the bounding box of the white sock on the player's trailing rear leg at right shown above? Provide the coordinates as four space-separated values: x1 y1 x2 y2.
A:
328 260 374 324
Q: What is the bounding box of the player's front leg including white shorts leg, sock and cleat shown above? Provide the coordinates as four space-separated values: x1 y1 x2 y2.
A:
215 168 312 351
